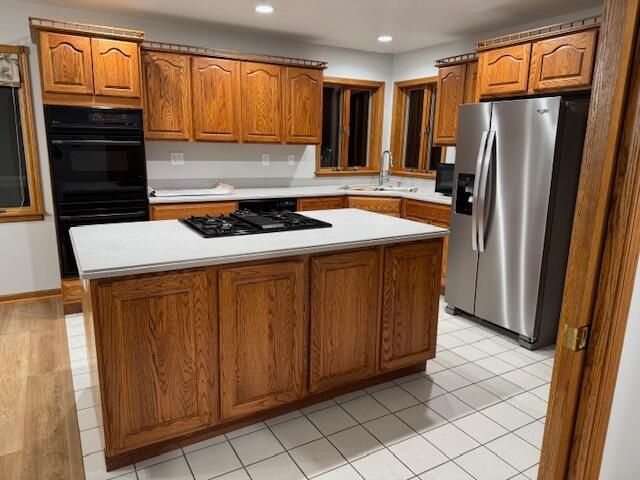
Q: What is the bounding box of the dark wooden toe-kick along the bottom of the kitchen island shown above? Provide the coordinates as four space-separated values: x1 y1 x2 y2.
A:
105 361 428 472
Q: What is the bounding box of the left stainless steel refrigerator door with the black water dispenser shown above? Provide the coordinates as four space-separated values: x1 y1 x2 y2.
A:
445 103 491 313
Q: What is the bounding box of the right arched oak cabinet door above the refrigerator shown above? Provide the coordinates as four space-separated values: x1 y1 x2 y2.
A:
529 29 598 93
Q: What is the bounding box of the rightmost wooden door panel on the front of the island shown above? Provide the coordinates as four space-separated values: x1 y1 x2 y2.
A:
381 240 442 370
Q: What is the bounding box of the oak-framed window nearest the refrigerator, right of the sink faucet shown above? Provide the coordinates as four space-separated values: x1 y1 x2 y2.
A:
391 77 446 177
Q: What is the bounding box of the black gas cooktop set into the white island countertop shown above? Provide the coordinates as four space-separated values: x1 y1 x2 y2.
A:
180 210 331 238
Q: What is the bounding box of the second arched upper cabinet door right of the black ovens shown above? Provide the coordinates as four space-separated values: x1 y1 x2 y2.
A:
191 57 240 142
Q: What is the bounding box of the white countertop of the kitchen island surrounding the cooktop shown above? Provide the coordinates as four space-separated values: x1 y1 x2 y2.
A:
70 208 449 280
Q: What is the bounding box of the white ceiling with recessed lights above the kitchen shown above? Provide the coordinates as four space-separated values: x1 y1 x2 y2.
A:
27 0 602 53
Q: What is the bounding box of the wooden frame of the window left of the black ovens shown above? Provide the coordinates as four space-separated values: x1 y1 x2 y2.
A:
0 45 44 223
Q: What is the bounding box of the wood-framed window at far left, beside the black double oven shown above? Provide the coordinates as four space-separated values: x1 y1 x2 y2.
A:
0 45 43 222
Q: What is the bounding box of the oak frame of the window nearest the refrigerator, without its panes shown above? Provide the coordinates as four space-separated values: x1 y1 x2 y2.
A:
391 75 447 179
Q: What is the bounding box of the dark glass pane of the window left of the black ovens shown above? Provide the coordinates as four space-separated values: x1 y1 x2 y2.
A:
0 87 30 208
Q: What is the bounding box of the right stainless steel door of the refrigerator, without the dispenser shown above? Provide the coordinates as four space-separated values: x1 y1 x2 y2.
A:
474 97 560 338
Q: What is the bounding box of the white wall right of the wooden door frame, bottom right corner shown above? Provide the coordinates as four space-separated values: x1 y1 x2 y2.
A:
600 263 640 480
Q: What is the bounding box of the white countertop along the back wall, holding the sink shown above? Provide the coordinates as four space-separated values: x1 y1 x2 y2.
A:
149 185 451 205
